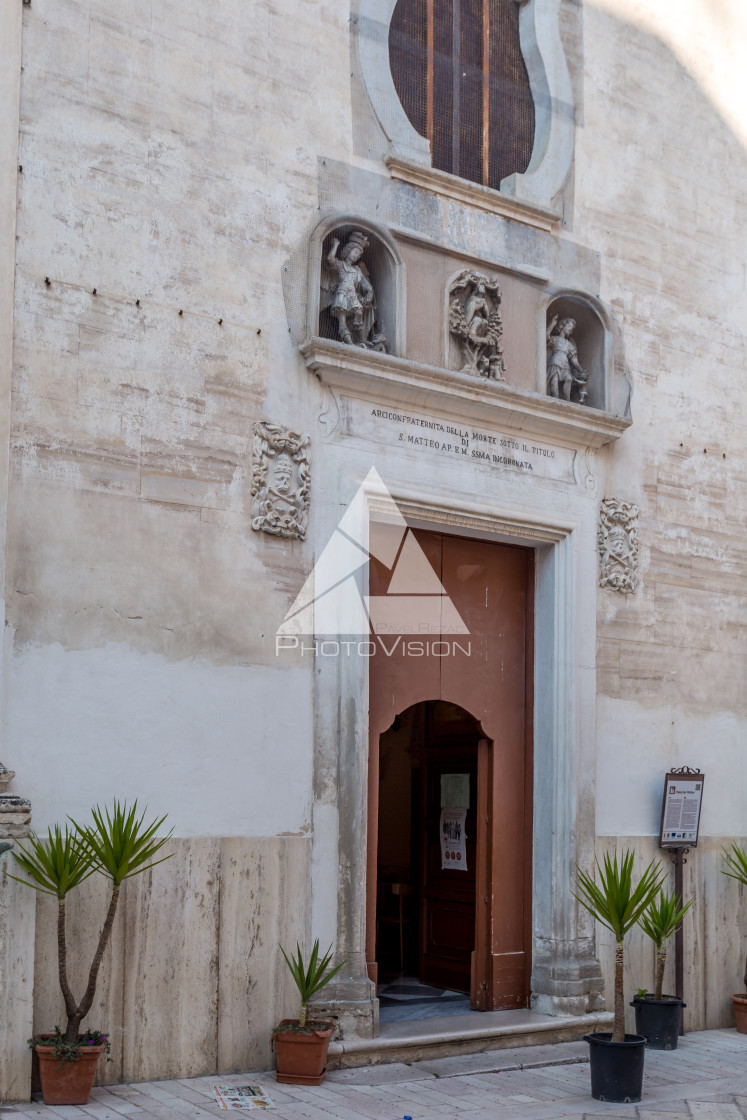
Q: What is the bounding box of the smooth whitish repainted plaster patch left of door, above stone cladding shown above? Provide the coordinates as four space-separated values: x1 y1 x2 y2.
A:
8 643 314 837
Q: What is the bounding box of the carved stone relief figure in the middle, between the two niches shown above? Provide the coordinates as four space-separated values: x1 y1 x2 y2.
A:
449 269 506 381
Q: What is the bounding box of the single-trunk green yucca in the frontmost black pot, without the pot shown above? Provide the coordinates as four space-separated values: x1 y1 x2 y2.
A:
573 849 664 1043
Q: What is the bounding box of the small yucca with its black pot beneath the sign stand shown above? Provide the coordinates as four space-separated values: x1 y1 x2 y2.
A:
631 890 692 1049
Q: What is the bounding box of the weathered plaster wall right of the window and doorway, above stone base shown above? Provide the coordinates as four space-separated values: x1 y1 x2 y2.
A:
573 0 747 836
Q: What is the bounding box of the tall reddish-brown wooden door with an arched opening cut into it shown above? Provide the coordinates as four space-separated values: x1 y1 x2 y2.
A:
366 531 533 1010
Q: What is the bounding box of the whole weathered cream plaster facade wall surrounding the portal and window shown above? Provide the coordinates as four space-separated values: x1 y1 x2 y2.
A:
0 0 747 1093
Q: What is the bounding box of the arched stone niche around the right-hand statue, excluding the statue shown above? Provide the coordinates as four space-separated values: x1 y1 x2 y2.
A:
538 290 613 412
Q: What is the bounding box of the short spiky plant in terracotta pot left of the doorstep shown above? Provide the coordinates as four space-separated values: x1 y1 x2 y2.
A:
272 937 345 1085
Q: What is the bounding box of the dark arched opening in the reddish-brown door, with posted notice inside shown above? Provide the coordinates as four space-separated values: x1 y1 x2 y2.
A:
376 700 484 1008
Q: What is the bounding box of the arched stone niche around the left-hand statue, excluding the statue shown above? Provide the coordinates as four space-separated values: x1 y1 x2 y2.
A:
306 214 405 356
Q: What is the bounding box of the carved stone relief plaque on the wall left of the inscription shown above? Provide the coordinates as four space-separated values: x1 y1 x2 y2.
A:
252 420 309 540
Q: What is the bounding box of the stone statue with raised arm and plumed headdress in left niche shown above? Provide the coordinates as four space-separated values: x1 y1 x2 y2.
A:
319 230 386 352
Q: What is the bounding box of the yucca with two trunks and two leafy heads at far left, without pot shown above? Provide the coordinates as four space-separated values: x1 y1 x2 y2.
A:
11 801 171 1043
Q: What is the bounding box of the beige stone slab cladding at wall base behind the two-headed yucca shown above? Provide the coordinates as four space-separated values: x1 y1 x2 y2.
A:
30 837 310 1079
